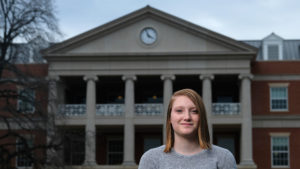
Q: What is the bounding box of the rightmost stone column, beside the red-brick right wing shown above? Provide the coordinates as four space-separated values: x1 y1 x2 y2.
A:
239 74 256 169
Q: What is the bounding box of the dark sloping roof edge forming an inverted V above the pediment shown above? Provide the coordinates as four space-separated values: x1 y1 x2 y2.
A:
43 6 257 56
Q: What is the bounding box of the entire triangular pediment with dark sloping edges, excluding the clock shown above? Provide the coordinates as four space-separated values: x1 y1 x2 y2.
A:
43 6 256 57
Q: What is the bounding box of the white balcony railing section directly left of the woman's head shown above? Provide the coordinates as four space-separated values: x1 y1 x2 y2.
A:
135 103 164 116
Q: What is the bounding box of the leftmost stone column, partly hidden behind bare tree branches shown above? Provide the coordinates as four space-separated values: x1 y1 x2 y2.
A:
47 76 63 163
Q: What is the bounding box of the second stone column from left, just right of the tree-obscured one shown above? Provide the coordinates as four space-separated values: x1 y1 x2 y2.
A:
83 75 98 165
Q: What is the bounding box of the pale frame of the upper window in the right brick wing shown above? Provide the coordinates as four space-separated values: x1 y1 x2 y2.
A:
269 83 289 112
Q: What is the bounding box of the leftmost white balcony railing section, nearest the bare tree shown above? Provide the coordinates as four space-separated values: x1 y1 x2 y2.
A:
58 104 86 116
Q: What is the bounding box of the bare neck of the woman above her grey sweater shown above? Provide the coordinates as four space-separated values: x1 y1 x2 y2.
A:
174 135 202 155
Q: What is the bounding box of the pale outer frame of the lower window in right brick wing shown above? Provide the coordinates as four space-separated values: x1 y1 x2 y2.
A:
270 133 290 168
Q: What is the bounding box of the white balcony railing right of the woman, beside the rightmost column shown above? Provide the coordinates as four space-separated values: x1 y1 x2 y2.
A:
212 103 240 115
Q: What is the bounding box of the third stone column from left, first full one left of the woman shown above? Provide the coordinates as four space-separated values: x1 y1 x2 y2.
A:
122 75 136 165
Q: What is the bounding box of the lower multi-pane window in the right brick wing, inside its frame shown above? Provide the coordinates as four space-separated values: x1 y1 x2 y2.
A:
271 136 289 167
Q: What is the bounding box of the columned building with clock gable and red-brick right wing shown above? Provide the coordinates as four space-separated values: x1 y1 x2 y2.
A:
2 6 300 169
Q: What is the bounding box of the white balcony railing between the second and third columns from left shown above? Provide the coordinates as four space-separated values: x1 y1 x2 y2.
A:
96 104 125 116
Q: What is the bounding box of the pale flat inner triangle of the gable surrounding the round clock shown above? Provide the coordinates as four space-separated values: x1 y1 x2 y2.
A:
66 18 232 53
